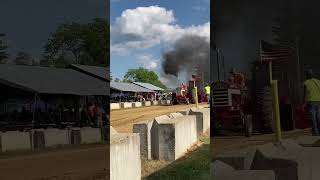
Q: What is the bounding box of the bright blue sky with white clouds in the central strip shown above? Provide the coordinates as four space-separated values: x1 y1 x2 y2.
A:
110 0 210 82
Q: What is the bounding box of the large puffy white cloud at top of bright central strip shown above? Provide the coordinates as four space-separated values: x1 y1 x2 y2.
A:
111 6 210 55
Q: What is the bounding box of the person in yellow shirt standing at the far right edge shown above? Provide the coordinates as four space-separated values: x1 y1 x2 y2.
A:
304 69 320 136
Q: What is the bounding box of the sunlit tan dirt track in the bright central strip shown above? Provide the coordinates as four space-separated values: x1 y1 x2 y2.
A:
110 104 202 133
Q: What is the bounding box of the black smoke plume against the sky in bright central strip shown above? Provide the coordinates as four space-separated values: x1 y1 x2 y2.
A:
162 35 210 83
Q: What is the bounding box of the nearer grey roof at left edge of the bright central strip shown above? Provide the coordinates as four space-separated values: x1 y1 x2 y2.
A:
110 82 154 92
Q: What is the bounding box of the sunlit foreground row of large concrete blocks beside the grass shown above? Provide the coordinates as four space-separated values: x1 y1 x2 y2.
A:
110 109 210 180
